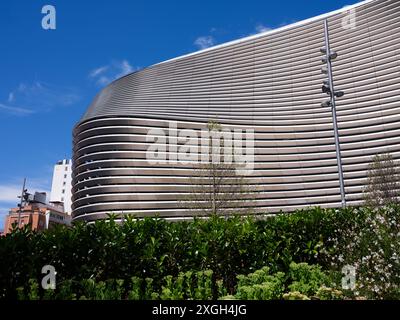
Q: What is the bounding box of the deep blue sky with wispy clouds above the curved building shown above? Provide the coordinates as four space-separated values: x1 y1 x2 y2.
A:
0 0 357 229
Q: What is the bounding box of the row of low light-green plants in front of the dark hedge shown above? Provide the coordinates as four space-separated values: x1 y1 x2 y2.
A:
17 263 343 300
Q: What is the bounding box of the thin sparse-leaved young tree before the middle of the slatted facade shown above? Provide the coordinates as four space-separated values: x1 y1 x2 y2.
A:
182 121 252 215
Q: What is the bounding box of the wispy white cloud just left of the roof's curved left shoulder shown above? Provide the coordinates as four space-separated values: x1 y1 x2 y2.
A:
89 60 139 86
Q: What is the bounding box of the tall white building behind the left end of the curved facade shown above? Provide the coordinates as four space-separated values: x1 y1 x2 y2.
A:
50 159 72 214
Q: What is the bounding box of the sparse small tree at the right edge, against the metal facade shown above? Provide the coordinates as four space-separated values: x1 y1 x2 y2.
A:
364 154 400 207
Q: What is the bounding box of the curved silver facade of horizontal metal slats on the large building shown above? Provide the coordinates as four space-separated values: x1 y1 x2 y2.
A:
73 0 400 220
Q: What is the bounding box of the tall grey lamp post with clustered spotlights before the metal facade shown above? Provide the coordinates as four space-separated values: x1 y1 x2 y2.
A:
321 19 346 207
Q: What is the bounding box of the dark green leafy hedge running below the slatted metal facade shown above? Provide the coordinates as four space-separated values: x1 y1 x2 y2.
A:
0 208 400 299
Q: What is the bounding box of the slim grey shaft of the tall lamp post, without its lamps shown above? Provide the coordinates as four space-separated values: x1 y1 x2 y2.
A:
324 19 346 207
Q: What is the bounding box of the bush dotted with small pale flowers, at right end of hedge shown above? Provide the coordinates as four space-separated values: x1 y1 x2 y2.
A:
329 206 400 299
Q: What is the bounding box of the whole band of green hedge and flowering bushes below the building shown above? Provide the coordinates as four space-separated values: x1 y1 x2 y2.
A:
0 206 400 299
